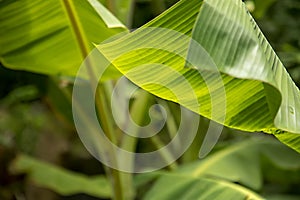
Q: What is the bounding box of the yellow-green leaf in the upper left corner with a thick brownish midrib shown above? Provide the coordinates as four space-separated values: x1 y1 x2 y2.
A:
0 0 126 78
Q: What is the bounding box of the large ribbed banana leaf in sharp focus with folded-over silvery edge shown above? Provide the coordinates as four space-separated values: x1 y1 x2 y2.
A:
98 0 300 152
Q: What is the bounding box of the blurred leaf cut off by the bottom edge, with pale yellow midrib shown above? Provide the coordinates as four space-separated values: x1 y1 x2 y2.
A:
144 174 263 200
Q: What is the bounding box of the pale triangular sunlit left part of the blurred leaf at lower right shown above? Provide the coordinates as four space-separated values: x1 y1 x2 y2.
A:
179 138 262 190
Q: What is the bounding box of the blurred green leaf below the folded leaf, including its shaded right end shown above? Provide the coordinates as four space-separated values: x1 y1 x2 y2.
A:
178 136 300 191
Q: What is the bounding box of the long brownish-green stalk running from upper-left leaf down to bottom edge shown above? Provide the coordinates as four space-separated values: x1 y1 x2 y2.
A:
62 0 126 200
